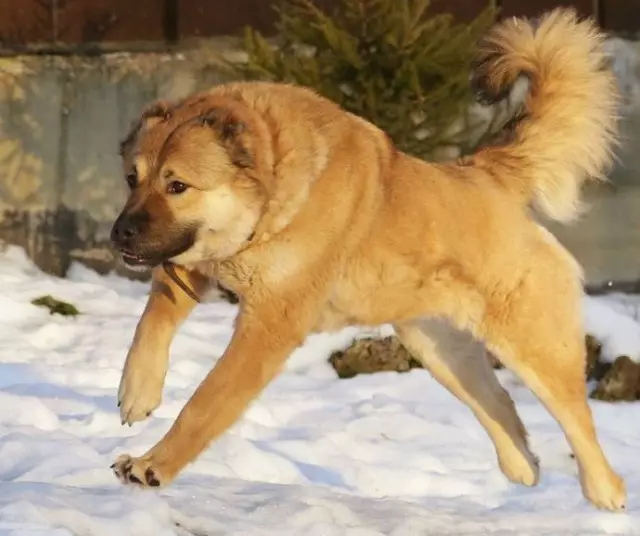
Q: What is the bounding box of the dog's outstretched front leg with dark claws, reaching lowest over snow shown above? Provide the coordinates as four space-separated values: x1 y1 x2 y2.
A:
112 303 311 487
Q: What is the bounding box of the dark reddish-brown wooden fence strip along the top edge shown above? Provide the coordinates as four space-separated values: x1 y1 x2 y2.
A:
0 0 640 54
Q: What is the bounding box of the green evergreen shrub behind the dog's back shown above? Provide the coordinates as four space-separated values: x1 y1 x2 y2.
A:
235 0 495 159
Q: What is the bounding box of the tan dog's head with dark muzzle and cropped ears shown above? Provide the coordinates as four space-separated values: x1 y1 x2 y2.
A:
111 96 267 267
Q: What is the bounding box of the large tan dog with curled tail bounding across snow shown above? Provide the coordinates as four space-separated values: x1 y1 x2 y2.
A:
113 10 625 510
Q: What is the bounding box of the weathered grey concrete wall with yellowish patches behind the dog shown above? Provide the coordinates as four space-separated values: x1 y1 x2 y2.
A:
0 39 640 285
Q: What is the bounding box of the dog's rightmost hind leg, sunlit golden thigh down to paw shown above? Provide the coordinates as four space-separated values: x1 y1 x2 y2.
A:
478 252 626 510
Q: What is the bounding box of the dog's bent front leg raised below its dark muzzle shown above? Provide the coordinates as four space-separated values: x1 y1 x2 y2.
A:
118 267 209 426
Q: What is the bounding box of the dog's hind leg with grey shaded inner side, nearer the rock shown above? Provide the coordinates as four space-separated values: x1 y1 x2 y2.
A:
395 319 539 486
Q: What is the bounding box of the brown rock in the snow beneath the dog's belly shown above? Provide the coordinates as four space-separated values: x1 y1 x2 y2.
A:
329 337 421 378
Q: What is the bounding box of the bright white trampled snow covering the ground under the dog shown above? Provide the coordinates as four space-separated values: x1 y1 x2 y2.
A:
0 244 640 536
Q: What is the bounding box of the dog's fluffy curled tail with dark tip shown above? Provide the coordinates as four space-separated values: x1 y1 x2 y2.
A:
472 8 618 221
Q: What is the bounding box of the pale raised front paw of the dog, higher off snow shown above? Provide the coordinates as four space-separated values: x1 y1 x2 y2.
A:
118 360 164 426
